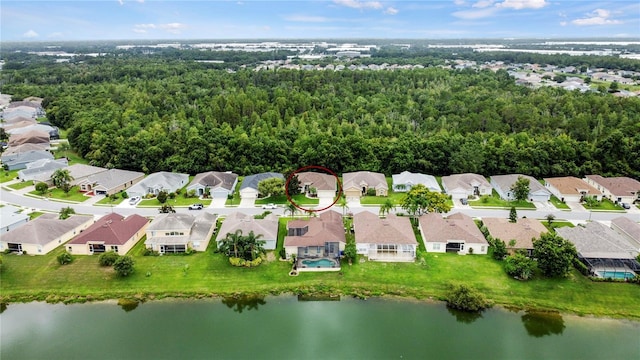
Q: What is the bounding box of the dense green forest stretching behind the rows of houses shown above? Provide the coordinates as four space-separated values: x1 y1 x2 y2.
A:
2 54 640 178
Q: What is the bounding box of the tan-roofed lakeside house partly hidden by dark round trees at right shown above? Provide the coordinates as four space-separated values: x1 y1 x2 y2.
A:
482 218 549 256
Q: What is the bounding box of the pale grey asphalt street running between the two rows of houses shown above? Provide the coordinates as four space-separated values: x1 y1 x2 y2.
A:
0 188 640 222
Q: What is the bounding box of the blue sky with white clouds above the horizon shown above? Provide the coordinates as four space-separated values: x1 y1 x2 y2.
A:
0 0 640 42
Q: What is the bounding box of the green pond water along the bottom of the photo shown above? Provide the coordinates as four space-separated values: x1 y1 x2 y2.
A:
0 296 640 360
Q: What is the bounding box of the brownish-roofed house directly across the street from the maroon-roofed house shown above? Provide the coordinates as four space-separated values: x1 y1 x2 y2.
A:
77 169 144 195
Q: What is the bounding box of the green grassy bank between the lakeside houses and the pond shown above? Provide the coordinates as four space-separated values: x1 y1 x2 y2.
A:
0 249 640 320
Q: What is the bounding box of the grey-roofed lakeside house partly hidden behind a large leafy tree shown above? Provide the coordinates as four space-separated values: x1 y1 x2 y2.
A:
216 212 278 250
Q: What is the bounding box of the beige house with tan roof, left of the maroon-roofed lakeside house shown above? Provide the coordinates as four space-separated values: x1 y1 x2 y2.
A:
0 214 93 255
